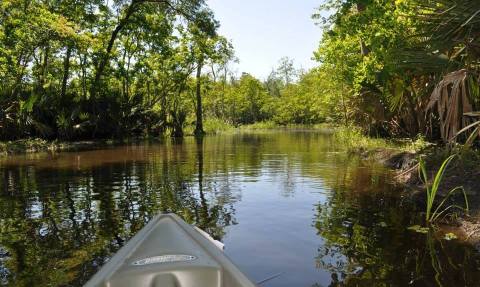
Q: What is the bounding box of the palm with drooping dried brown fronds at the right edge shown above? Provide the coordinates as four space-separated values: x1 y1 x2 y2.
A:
414 0 480 142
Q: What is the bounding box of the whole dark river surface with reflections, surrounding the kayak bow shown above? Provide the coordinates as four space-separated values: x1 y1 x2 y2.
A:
0 131 480 287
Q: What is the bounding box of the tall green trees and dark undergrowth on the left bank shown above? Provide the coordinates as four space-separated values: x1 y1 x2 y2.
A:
0 0 231 139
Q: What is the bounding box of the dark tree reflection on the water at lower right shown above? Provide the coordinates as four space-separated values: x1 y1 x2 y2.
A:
315 168 480 286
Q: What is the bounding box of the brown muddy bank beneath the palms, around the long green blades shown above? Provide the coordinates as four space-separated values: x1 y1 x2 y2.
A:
360 149 480 246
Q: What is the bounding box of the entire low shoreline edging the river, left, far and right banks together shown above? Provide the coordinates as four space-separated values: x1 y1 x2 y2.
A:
0 127 480 244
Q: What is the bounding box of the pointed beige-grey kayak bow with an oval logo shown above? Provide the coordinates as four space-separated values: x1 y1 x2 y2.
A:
85 214 255 287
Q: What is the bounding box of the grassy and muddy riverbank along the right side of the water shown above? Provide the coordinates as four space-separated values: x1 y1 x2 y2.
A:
326 128 480 246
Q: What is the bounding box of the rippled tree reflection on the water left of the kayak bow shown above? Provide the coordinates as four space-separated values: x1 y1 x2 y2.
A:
0 139 233 286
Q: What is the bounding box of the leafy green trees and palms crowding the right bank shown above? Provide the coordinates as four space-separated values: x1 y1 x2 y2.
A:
314 0 480 140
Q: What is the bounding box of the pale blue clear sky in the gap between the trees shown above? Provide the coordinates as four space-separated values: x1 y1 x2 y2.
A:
207 0 322 79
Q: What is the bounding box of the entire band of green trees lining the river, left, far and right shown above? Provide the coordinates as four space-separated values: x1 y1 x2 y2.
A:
0 0 480 142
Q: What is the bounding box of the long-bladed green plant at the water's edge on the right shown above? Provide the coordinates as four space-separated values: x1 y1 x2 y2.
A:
419 155 468 224
